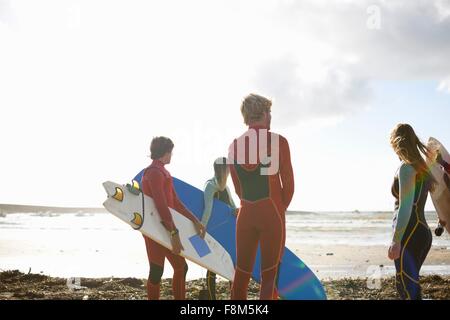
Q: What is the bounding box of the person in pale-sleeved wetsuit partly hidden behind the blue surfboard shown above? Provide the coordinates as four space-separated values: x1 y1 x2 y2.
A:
200 157 237 300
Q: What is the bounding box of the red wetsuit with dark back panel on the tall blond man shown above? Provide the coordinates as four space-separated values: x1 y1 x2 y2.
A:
229 126 294 300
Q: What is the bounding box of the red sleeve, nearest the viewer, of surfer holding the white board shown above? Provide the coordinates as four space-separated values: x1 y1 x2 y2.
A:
147 169 175 231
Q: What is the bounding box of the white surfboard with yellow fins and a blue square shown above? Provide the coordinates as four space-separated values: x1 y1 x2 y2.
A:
103 181 234 281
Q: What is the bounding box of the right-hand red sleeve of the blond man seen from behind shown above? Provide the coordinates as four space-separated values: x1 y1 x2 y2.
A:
280 136 294 209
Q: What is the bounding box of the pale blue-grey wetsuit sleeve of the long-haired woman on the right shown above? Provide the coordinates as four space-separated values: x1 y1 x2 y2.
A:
393 164 416 243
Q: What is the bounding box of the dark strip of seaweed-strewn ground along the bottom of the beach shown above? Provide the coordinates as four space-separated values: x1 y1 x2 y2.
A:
0 270 450 300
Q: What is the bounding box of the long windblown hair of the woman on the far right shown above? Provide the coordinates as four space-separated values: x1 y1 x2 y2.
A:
391 123 436 187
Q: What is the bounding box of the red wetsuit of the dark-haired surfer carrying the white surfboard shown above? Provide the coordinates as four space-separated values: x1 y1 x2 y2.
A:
142 160 198 300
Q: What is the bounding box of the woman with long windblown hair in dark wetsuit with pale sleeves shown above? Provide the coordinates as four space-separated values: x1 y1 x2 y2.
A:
388 124 436 300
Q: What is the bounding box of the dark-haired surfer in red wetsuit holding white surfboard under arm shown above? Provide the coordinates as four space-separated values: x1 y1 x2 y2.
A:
142 137 205 300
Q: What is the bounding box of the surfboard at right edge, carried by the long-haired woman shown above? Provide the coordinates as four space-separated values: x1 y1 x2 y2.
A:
427 138 450 233
